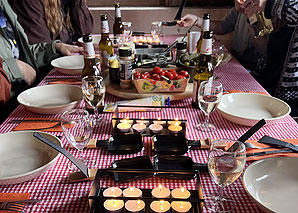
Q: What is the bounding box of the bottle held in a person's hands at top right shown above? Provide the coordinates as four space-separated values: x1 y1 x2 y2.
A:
248 12 273 38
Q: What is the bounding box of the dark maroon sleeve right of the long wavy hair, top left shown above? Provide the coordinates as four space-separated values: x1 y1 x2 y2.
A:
69 0 93 41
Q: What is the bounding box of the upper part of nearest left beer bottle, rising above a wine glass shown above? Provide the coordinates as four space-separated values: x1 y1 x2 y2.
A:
82 34 100 78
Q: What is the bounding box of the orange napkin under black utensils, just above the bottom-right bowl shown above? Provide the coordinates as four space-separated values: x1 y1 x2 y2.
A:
225 139 298 161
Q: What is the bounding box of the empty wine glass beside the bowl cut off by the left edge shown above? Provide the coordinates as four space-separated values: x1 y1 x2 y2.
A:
61 109 92 171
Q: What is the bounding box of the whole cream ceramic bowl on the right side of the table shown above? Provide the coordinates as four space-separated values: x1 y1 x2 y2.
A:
217 93 291 126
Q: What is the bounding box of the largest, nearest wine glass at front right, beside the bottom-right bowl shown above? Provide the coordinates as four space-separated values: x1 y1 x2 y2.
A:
204 139 246 212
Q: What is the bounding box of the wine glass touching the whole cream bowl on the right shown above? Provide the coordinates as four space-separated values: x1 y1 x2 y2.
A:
196 80 222 132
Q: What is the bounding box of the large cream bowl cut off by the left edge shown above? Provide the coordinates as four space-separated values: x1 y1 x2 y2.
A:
0 131 62 185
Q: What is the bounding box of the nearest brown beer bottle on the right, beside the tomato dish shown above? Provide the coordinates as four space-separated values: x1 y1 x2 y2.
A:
192 31 214 108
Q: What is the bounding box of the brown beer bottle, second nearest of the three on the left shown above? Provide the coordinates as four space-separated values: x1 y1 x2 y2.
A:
99 14 114 69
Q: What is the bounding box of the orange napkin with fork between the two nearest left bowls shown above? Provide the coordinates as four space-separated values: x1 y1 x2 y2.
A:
13 118 62 132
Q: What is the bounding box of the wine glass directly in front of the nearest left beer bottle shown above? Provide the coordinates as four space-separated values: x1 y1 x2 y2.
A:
82 76 106 125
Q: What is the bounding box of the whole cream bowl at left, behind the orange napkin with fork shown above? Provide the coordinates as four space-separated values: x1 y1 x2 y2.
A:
17 84 83 114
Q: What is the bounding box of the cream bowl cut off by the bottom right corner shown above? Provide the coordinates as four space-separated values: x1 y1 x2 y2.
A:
243 157 298 213
